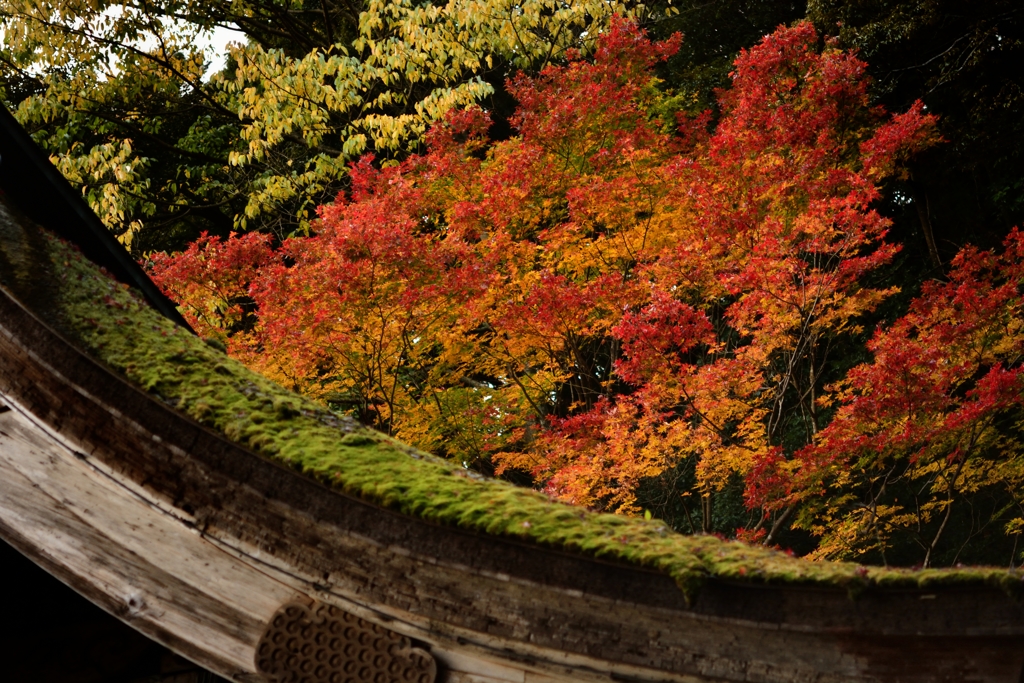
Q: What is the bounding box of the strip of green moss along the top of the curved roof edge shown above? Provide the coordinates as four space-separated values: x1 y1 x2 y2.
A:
47 233 1024 600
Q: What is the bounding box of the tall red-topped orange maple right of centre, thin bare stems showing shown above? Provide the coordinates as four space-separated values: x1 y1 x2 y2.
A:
489 25 930 530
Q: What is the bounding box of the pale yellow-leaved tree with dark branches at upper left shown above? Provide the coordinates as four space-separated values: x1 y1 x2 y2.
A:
0 0 629 253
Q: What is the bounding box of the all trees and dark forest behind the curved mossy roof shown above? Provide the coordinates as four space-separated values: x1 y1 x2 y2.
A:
0 0 1024 566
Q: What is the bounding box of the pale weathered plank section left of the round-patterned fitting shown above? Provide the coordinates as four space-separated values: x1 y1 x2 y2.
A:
0 403 301 681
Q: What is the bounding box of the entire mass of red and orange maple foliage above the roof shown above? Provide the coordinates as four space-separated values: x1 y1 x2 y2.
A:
154 20 1022 564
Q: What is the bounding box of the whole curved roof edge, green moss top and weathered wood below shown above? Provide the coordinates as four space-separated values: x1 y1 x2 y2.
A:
0 114 1024 683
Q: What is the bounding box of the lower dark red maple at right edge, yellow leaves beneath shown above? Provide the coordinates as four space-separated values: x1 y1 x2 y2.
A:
751 230 1024 566
